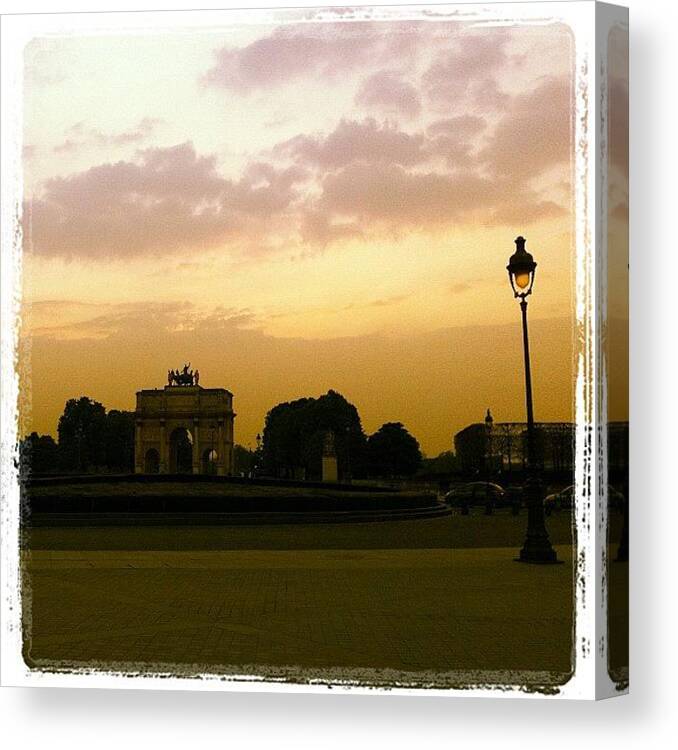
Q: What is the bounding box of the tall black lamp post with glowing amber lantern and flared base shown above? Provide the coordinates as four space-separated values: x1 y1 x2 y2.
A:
506 237 558 564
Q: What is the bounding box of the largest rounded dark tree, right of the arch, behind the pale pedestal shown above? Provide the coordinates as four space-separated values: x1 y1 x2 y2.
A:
262 390 366 479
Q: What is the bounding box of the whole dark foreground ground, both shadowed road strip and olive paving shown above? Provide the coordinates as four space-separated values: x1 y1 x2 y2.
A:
19 512 623 686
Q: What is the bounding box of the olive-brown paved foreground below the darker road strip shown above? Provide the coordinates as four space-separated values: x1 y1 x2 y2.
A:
23 546 573 684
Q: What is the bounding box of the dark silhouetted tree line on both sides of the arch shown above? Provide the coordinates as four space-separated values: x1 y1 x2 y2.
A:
19 390 436 479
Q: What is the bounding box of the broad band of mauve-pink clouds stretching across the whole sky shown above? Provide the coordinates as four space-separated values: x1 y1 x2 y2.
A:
24 63 571 261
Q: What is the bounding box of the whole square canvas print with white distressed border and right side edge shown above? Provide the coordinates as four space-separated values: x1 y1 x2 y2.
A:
3 3 629 697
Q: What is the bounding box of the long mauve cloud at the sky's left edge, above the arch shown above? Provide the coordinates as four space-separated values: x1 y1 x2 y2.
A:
24 143 303 259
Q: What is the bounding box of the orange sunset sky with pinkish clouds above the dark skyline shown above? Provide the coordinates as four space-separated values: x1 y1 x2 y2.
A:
21 14 596 455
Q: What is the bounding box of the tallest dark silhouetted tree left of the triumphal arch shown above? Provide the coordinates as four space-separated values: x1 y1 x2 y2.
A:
57 396 106 471
